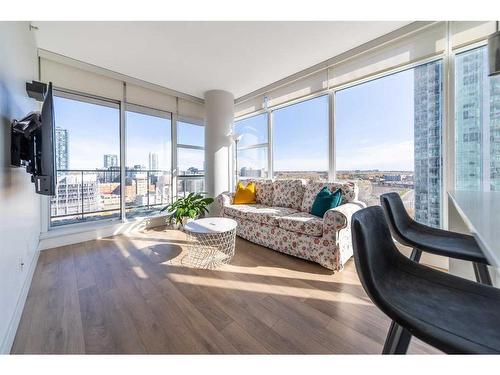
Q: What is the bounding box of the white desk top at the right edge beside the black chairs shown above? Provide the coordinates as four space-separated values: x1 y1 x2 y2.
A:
448 191 500 268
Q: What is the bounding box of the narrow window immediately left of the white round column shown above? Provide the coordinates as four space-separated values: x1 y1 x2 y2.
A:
177 121 205 197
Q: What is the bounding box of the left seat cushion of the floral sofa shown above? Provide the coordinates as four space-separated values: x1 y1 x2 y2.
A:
224 204 298 227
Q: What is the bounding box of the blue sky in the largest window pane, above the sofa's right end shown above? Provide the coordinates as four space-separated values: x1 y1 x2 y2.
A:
335 69 414 171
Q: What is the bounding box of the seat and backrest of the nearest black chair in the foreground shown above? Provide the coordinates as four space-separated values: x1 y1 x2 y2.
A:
351 206 500 354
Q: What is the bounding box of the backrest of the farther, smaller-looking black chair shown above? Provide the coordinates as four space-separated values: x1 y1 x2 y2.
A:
380 193 413 246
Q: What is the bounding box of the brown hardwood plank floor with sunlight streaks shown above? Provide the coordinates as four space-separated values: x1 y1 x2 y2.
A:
12 229 437 354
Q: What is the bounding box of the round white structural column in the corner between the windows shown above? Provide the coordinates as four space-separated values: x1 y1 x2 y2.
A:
205 90 234 209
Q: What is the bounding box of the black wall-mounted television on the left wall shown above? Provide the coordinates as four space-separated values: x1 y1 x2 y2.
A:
11 82 56 196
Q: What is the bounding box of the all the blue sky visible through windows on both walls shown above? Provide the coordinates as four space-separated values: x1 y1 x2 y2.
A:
55 69 413 171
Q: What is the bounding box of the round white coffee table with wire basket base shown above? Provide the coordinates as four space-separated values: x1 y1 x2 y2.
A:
184 217 238 269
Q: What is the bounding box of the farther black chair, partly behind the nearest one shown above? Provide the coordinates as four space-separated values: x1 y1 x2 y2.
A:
380 193 492 285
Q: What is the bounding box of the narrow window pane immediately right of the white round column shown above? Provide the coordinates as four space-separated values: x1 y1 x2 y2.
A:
234 113 268 178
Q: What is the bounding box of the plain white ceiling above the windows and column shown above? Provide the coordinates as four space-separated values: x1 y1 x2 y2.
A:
34 21 409 98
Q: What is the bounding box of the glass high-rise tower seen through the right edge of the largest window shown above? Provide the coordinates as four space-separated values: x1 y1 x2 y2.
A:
413 62 442 227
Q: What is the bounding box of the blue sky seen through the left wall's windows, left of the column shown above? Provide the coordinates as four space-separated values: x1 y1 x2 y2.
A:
54 97 204 170
